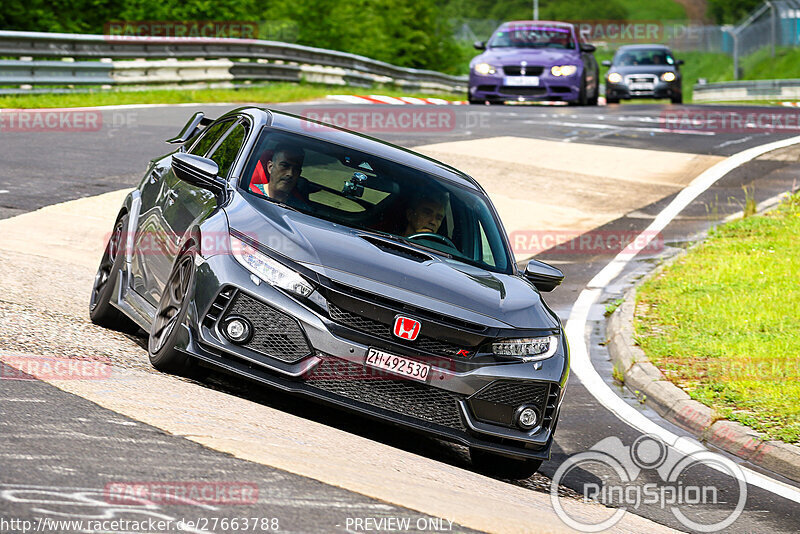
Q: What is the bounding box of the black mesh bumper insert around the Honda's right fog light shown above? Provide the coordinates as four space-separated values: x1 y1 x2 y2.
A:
469 380 558 428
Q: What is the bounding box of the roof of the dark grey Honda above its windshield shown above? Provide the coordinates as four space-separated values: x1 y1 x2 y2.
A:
220 107 485 194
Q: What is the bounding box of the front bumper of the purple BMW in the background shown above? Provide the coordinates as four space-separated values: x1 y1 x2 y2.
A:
469 72 581 102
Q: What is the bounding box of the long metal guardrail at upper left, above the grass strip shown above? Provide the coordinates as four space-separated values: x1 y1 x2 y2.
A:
0 30 467 93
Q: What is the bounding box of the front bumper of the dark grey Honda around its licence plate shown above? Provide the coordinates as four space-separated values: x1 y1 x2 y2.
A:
177 255 568 460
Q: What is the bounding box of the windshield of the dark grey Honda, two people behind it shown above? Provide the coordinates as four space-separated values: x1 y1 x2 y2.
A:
241 128 512 273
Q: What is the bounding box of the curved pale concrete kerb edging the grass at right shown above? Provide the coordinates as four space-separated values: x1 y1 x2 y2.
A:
606 264 800 482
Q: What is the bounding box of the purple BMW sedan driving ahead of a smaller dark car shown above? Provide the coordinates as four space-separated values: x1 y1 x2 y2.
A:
467 20 599 106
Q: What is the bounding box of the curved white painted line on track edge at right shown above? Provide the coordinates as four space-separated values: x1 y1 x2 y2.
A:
565 137 800 503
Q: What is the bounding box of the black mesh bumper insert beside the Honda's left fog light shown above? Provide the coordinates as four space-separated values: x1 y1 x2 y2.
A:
225 292 311 363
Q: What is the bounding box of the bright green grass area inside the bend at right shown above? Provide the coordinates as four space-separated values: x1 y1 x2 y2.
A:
635 194 800 444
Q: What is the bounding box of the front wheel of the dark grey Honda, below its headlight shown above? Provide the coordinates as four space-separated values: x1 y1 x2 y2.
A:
147 248 195 375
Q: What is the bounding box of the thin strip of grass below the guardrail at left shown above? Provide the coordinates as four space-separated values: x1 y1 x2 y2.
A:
0 83 466 109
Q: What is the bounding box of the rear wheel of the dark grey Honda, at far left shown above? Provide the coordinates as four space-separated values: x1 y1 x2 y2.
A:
89 214 139 334
